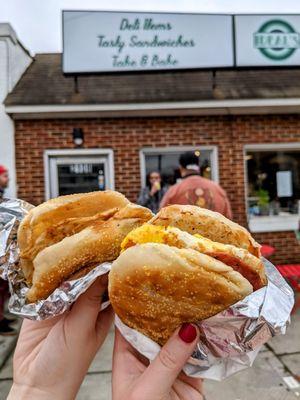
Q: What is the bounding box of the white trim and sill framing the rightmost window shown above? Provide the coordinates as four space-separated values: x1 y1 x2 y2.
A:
243 142 300 232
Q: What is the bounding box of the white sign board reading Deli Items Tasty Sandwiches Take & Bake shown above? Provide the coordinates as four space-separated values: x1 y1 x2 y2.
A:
63 11 233 73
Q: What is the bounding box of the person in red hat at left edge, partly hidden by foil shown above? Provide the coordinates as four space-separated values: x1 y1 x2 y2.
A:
0 165 16 336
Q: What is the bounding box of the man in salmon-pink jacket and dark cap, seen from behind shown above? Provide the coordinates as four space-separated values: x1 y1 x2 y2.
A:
160 151 232 219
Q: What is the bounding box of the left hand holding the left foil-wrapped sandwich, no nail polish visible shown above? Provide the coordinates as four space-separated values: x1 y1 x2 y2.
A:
8 276 113 400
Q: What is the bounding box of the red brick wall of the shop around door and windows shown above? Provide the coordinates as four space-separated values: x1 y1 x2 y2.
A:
16 115 300 262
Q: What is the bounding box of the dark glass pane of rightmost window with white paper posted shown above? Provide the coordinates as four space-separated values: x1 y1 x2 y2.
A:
246 150 300 215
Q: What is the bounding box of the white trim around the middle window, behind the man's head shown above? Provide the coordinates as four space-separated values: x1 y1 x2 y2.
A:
140 145 219 187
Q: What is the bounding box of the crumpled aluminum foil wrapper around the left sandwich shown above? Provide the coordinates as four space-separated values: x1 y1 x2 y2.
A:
0 199 111 320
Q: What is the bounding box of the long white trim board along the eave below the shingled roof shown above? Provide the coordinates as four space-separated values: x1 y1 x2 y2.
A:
5 98 300 119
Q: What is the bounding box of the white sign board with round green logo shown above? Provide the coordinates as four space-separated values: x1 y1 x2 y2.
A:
234 15 300 67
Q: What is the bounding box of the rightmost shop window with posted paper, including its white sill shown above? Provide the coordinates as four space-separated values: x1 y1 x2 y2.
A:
245 144 300 232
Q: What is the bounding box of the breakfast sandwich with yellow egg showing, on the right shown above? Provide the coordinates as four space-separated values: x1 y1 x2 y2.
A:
109 205 267 344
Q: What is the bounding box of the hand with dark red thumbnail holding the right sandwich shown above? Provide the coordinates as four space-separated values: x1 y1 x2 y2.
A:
112 324 203 400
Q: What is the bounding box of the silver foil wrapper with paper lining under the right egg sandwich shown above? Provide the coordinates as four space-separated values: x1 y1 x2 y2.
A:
116 259 294 381
